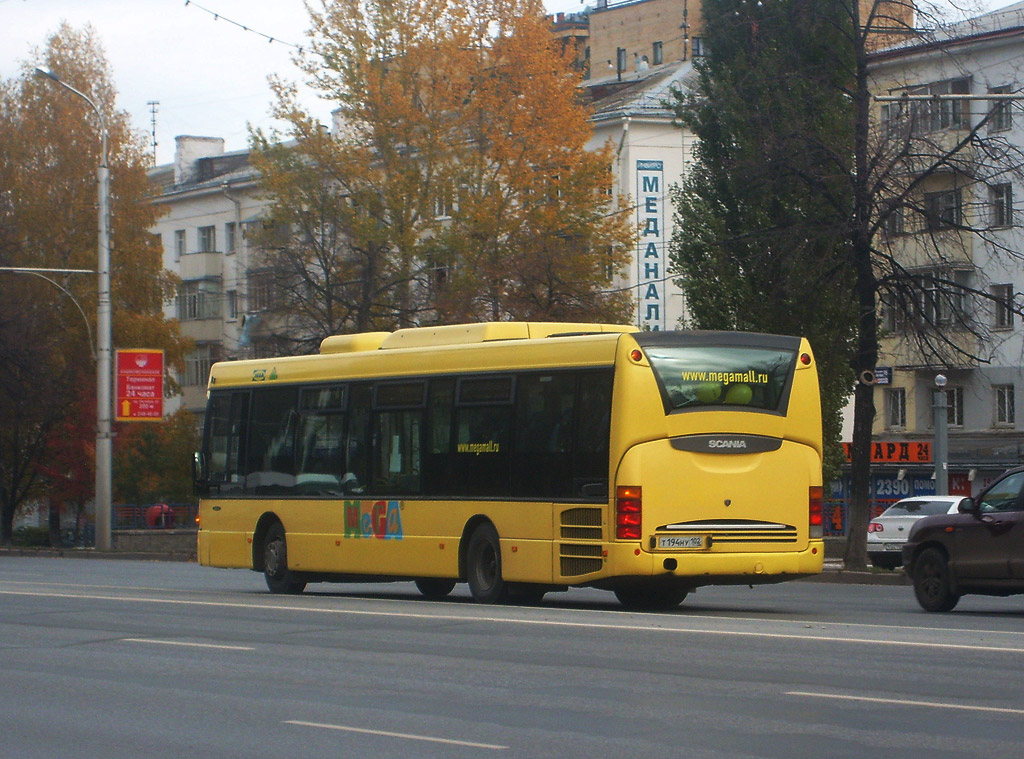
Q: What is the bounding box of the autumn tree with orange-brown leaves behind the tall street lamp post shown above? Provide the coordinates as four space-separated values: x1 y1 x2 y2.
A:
0 25 186 542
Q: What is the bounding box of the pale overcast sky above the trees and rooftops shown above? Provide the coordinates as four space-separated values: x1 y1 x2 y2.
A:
0 0 1011 163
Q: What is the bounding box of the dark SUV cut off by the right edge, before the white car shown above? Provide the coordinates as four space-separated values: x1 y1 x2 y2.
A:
903 467 1024 612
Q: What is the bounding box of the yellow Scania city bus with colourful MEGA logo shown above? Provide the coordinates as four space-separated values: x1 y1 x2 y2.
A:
196 323 824 608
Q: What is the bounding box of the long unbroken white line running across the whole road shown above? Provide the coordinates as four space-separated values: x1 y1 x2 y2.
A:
6 589 1024 653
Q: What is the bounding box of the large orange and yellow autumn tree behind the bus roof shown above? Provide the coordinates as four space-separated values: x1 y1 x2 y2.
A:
254 0 634 347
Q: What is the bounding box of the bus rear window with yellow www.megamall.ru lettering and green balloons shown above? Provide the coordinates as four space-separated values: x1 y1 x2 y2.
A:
644 344 797 412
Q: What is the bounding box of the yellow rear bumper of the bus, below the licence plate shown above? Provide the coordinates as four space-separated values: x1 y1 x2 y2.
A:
590 540 825 588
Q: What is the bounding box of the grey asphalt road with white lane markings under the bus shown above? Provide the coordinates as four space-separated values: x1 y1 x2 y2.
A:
0 555 1024 759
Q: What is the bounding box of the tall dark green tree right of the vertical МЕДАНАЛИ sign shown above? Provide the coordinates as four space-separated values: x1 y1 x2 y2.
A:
670 0 856 476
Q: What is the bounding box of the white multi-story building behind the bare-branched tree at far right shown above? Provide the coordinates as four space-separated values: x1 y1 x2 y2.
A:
871 3 1024 497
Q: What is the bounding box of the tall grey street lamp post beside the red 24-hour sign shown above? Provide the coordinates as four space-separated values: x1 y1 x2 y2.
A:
36 69 114 551
